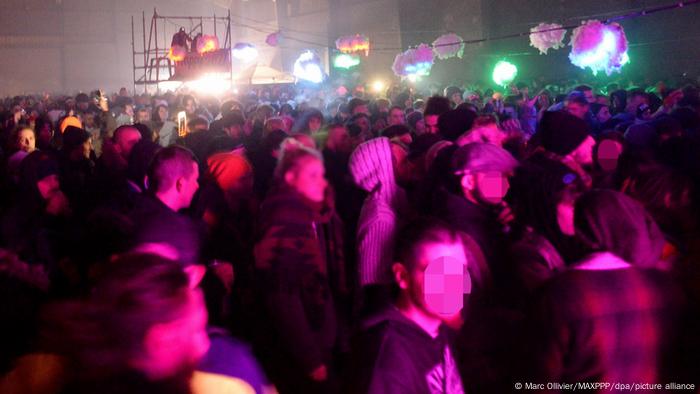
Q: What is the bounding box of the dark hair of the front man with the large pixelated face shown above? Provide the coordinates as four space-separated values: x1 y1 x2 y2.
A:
394 217 459 271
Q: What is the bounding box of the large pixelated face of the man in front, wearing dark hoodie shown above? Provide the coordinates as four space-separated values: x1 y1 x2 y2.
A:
410 242 471 319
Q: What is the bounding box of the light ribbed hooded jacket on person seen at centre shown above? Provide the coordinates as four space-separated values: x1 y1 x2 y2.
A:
349 137 408 286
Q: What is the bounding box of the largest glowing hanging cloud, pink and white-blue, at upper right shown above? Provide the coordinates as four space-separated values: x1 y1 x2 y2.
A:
569 20 629 75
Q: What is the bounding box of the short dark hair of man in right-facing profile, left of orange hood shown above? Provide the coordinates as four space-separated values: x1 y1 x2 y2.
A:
148 145 198 193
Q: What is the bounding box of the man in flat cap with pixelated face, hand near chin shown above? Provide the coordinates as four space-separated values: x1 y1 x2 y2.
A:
435 142 518 290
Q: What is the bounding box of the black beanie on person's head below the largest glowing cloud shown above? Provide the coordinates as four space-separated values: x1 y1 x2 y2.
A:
539 111 589 156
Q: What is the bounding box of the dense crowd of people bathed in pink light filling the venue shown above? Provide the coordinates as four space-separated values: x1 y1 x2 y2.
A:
0 75 700 394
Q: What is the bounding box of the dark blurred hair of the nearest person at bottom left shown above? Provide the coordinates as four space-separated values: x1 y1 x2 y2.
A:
42 254 189 377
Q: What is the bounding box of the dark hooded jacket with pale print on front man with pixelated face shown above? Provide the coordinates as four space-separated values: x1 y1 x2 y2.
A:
343 306 464 394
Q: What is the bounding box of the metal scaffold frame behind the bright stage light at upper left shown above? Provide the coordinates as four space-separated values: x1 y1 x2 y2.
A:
131 8 233 93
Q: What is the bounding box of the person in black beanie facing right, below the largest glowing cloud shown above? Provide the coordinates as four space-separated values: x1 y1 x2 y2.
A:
538 111 596 187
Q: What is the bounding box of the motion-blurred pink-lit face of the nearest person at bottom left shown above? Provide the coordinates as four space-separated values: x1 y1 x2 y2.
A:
144 289 210 378
